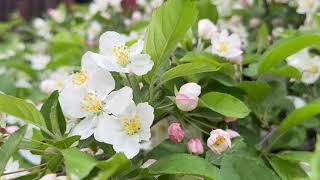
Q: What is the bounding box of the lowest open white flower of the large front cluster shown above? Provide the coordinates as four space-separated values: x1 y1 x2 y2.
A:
95 100 154 159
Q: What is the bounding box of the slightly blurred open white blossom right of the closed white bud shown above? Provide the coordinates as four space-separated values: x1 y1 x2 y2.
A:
211 30 242 59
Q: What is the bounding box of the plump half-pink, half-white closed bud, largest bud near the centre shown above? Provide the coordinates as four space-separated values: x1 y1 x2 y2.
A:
176 83 201 111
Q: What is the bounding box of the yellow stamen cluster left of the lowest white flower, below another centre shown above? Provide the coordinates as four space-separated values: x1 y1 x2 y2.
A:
81 92 103 113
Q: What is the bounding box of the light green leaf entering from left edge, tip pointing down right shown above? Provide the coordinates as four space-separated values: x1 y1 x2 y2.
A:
0 93 52 135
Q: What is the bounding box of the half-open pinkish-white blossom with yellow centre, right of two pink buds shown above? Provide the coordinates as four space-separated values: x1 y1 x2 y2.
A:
207 129 231 154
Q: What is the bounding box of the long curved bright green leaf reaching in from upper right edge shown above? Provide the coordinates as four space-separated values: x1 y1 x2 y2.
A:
258 32 320 74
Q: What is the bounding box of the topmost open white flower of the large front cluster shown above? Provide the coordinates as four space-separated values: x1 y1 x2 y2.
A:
95 31 153 76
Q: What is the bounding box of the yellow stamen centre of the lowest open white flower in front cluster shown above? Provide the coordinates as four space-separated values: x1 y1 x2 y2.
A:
122 114 141 135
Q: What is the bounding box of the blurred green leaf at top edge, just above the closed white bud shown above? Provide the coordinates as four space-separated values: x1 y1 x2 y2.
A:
197 0 219 23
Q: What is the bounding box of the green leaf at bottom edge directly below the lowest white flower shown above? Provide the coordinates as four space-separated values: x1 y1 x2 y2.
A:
96 153 131 180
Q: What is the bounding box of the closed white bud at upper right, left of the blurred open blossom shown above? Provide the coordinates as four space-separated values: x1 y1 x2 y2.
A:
198 19 218 40
